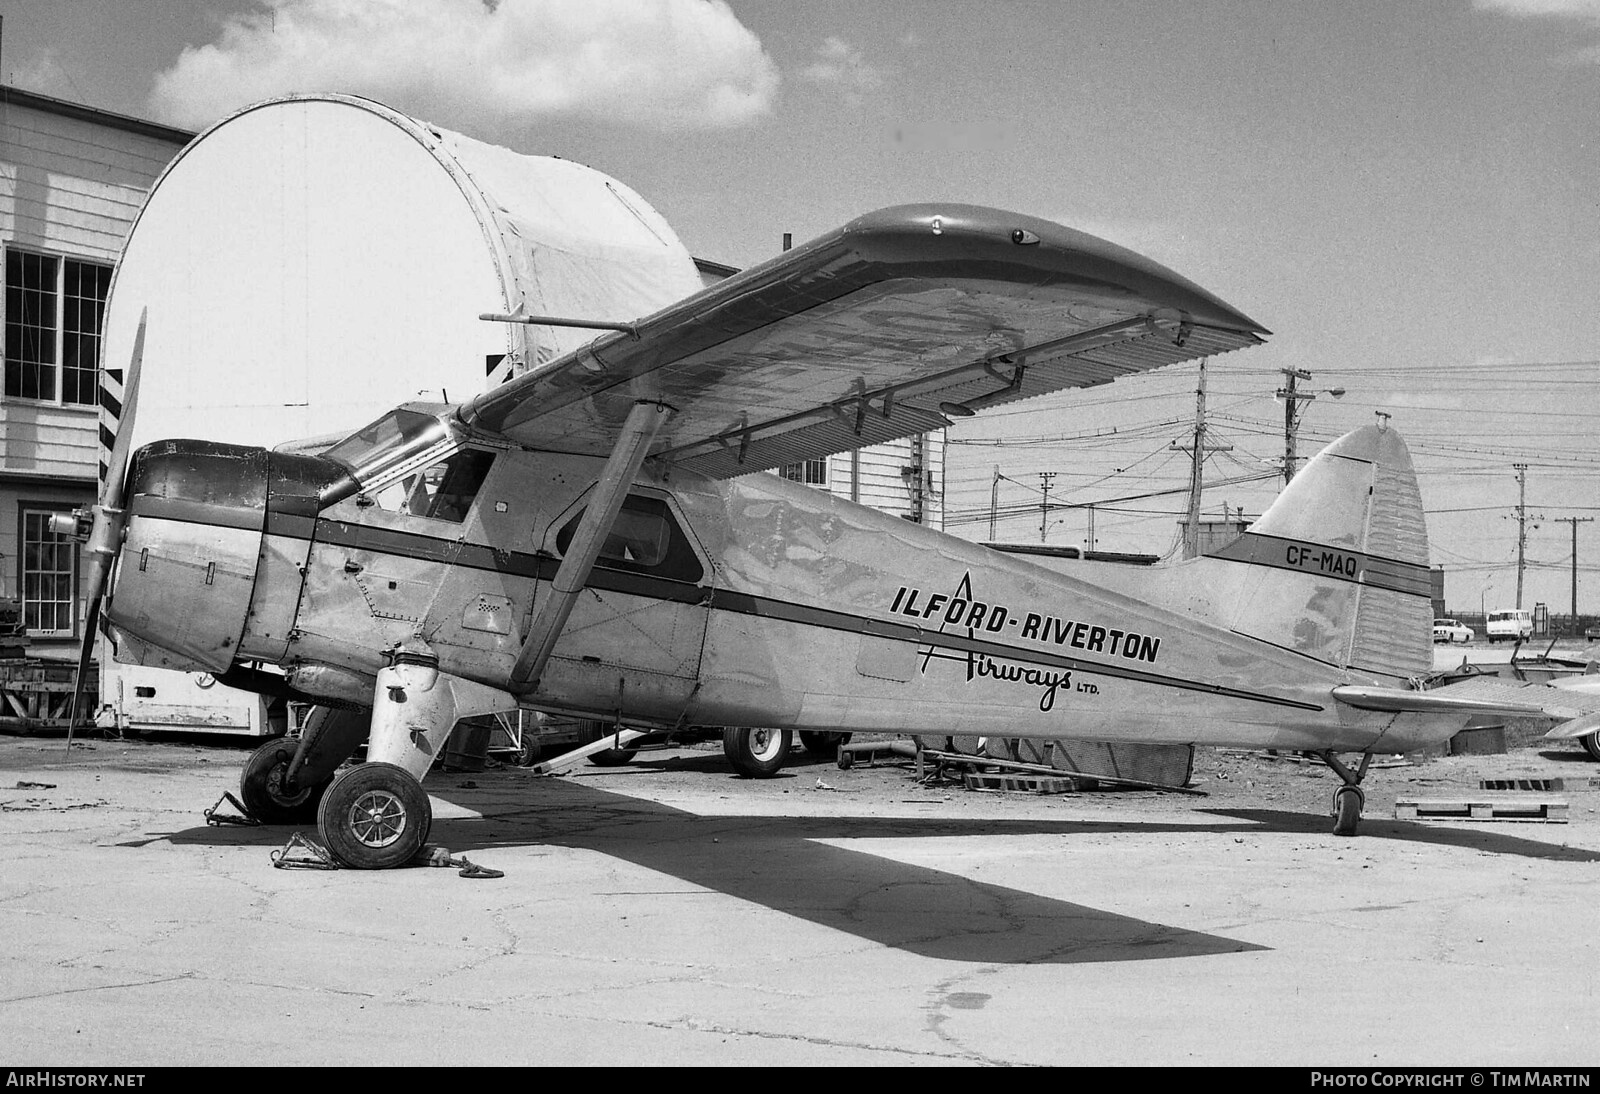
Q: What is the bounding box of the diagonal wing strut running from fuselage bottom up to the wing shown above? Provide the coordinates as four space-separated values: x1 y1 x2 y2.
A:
509 403 672 694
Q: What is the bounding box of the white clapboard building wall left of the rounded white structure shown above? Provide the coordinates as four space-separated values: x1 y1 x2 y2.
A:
0 88 189 656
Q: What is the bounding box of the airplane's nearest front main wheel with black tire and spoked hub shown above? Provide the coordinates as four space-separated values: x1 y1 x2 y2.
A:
317 763 434 870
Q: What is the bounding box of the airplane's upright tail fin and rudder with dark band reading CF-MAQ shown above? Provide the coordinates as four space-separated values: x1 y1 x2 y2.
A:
1211 425 1432 677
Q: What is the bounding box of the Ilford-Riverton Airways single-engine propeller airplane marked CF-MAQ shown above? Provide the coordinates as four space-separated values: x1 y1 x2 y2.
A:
50 205 1594 868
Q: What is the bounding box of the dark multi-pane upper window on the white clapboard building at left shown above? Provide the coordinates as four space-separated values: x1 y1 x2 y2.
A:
5 250 110 406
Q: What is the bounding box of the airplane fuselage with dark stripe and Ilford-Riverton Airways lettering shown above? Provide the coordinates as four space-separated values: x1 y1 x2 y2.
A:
107 431 1454 750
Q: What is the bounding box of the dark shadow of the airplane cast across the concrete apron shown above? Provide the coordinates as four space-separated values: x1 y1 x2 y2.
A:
144 781 1600 964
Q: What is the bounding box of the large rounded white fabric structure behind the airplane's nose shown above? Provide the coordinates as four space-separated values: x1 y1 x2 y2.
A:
102 94 701 446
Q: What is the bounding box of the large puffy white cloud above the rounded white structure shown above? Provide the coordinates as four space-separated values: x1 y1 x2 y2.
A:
150 0 779 130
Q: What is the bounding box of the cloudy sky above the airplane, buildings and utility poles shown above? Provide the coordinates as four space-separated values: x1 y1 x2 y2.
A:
0 0 1600 613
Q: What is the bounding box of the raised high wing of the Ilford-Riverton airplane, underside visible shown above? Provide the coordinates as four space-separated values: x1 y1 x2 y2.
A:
459 205 1267 478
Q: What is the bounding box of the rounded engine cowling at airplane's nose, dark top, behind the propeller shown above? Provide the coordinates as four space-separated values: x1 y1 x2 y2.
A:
106 440 267 672
